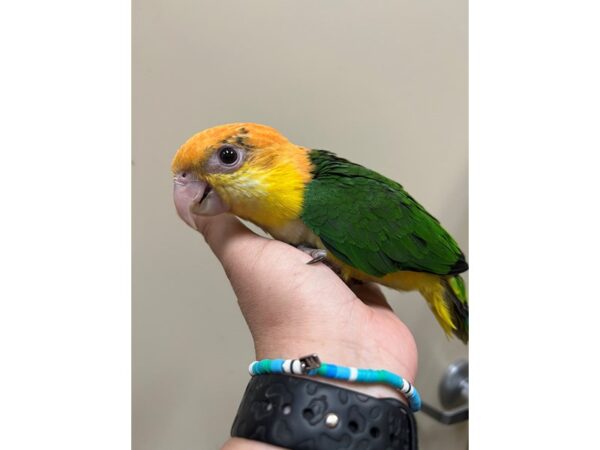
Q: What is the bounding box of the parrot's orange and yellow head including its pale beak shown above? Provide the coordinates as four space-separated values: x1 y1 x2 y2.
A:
171 123 311 227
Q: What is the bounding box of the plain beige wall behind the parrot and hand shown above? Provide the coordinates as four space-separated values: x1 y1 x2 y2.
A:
134 0 468 450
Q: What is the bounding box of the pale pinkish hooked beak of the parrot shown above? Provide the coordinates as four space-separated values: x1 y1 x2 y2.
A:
173 173 229 229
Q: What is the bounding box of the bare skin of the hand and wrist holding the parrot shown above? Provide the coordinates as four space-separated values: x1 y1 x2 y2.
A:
186 214 417 450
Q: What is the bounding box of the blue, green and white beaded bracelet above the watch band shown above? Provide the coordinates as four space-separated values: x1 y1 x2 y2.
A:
248 354 421 412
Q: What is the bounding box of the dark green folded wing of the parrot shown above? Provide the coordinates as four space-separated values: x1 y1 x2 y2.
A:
301 150 468 277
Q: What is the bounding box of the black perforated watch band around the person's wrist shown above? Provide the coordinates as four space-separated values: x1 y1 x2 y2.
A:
231 374 417 450
